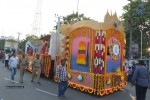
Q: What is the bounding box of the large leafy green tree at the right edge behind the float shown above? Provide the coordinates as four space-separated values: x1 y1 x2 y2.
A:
122 0 150 58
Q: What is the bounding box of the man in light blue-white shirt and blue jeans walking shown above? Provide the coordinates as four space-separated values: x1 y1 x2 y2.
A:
9 52 19 81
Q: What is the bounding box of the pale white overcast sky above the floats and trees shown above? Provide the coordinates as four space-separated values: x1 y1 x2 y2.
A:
0 0 129 39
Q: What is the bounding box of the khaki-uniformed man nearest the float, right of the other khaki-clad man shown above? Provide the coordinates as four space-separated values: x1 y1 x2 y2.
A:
31 54 42 84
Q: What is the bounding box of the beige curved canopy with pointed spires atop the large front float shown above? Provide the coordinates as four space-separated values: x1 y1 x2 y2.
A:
60 11 125 36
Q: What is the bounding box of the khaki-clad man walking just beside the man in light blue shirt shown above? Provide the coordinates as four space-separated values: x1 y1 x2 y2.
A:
19 54 28 83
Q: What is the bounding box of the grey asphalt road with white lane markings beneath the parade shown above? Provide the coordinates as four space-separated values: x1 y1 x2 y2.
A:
0 62 150 100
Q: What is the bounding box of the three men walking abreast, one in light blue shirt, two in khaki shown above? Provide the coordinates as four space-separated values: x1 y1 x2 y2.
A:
8 51 42 84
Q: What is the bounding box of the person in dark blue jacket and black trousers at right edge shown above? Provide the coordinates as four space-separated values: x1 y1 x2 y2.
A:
132 60 150 100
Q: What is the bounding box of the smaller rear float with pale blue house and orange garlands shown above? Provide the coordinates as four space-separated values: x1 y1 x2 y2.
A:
25 35 51 78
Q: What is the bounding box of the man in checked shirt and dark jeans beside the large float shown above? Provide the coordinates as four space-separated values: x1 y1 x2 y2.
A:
56 59 68 98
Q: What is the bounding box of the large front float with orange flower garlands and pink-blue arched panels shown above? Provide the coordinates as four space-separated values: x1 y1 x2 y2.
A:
55 12 126 96
